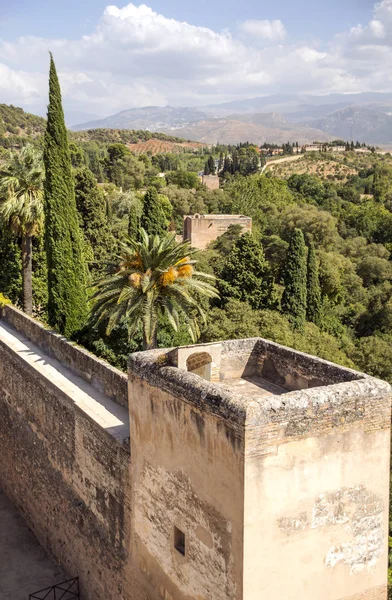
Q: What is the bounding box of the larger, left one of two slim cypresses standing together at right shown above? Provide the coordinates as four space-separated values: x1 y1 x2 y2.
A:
282 229 307 329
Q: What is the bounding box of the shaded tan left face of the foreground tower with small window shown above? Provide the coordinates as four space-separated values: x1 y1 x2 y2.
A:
129 352 244 600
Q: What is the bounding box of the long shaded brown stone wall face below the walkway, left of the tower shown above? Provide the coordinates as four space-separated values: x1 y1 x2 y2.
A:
0 316 156 600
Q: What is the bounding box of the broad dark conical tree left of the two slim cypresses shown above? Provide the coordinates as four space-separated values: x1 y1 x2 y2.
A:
218 233 274 309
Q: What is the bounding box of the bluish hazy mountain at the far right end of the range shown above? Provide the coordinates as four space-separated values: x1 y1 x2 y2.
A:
303 106 392 144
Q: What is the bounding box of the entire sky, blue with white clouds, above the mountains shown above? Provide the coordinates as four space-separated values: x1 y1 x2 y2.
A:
0 0 392 122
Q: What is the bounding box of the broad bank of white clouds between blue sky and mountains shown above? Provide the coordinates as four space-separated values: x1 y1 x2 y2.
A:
0 0 392 116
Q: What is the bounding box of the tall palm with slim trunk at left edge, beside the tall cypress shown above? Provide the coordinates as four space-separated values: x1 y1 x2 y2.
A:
0 144 44 315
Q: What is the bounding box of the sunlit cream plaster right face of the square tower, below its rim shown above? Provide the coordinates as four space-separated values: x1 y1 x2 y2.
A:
244 427 389 600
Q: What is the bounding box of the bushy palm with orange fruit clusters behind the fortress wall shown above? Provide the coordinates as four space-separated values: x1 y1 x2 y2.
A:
92 229 218 350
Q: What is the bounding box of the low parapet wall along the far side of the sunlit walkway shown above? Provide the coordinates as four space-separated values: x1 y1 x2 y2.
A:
0 305 128 407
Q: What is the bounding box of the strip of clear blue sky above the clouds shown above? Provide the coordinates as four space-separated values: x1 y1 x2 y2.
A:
0 0 374 41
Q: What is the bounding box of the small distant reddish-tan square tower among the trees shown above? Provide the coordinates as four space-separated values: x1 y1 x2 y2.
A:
184 215 252 250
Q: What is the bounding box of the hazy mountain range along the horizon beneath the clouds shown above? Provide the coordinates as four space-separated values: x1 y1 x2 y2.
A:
71 92 392 146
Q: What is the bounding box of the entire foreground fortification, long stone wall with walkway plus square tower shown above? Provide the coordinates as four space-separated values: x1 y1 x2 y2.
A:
0 307 391 600
